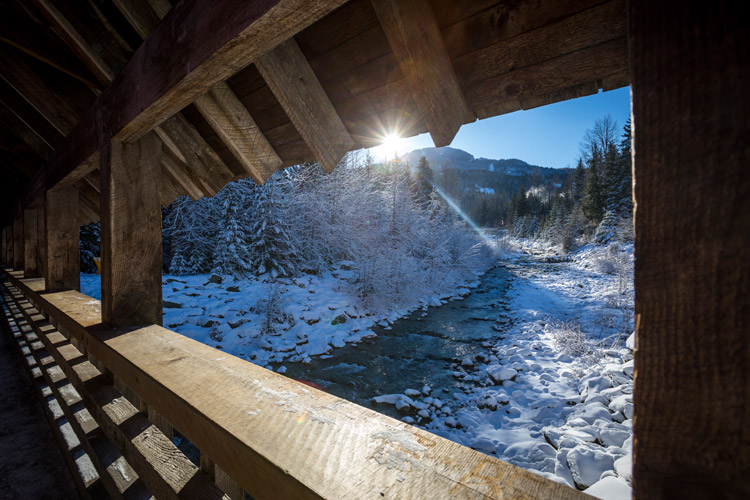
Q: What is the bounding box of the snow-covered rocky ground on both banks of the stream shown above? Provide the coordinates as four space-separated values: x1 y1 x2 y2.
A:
81 237 633 499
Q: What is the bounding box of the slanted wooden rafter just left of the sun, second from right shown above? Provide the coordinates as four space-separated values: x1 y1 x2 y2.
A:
255 38 354 172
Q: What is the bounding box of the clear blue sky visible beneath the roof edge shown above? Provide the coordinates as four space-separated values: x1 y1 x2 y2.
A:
372 87 630 168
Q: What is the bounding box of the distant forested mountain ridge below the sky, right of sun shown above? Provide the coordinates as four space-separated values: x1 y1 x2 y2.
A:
401 147 560 177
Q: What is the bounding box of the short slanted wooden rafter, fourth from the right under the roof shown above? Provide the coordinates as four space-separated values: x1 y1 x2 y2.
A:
155 113 234 196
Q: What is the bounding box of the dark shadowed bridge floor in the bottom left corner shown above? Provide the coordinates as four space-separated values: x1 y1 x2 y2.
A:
0 304 79 500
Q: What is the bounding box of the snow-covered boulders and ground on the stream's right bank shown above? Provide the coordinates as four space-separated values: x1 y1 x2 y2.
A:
375 241 633 499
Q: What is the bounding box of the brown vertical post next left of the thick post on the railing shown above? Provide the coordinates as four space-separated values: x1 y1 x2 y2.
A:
44 186 81 292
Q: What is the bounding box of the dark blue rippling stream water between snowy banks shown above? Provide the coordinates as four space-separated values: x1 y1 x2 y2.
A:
284 264 511 416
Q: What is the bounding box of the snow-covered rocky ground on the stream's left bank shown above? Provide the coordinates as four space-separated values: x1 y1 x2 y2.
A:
81 262 489 372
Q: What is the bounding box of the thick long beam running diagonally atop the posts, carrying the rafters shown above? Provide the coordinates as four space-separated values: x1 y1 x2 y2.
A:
21 0 346 212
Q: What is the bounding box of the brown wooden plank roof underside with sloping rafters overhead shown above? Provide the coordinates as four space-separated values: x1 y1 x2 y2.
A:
0 0 629 222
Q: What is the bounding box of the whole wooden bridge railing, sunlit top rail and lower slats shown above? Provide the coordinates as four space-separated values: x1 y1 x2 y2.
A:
3 271 584 500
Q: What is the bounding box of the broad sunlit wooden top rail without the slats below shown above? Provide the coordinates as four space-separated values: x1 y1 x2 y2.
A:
1 271 585 499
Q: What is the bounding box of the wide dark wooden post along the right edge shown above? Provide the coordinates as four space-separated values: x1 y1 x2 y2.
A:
628 0 750 500
